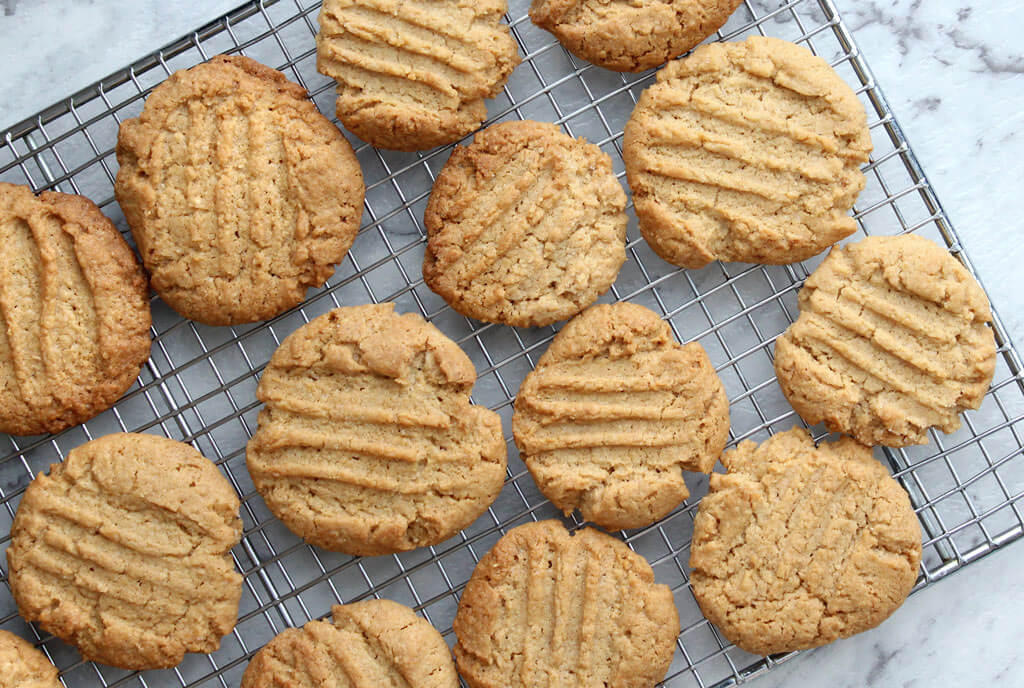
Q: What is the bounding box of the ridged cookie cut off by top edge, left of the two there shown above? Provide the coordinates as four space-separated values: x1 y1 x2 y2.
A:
316 0 519 151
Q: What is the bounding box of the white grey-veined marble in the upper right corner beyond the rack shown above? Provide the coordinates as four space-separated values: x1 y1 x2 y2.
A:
838 0 1024 342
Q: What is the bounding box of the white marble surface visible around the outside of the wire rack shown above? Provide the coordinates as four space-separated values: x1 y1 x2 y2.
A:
0 0 1024 688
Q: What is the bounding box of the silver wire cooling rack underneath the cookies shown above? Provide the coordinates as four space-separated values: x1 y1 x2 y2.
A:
0 0 1024 688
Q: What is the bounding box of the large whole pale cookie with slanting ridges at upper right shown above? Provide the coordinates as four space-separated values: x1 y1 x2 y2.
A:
623 37 871 268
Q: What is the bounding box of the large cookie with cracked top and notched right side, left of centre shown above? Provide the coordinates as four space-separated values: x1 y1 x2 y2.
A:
246 303 506 555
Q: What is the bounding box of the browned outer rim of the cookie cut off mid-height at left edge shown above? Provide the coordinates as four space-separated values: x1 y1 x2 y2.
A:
0 182 153 435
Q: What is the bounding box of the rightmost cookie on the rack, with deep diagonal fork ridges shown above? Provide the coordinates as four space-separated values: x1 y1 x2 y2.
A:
775 234 995 446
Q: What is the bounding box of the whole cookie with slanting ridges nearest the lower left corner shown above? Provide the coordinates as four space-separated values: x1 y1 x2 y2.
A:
7 433 242 670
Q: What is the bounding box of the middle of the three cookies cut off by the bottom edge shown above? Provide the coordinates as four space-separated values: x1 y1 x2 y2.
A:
242 600 459 688
